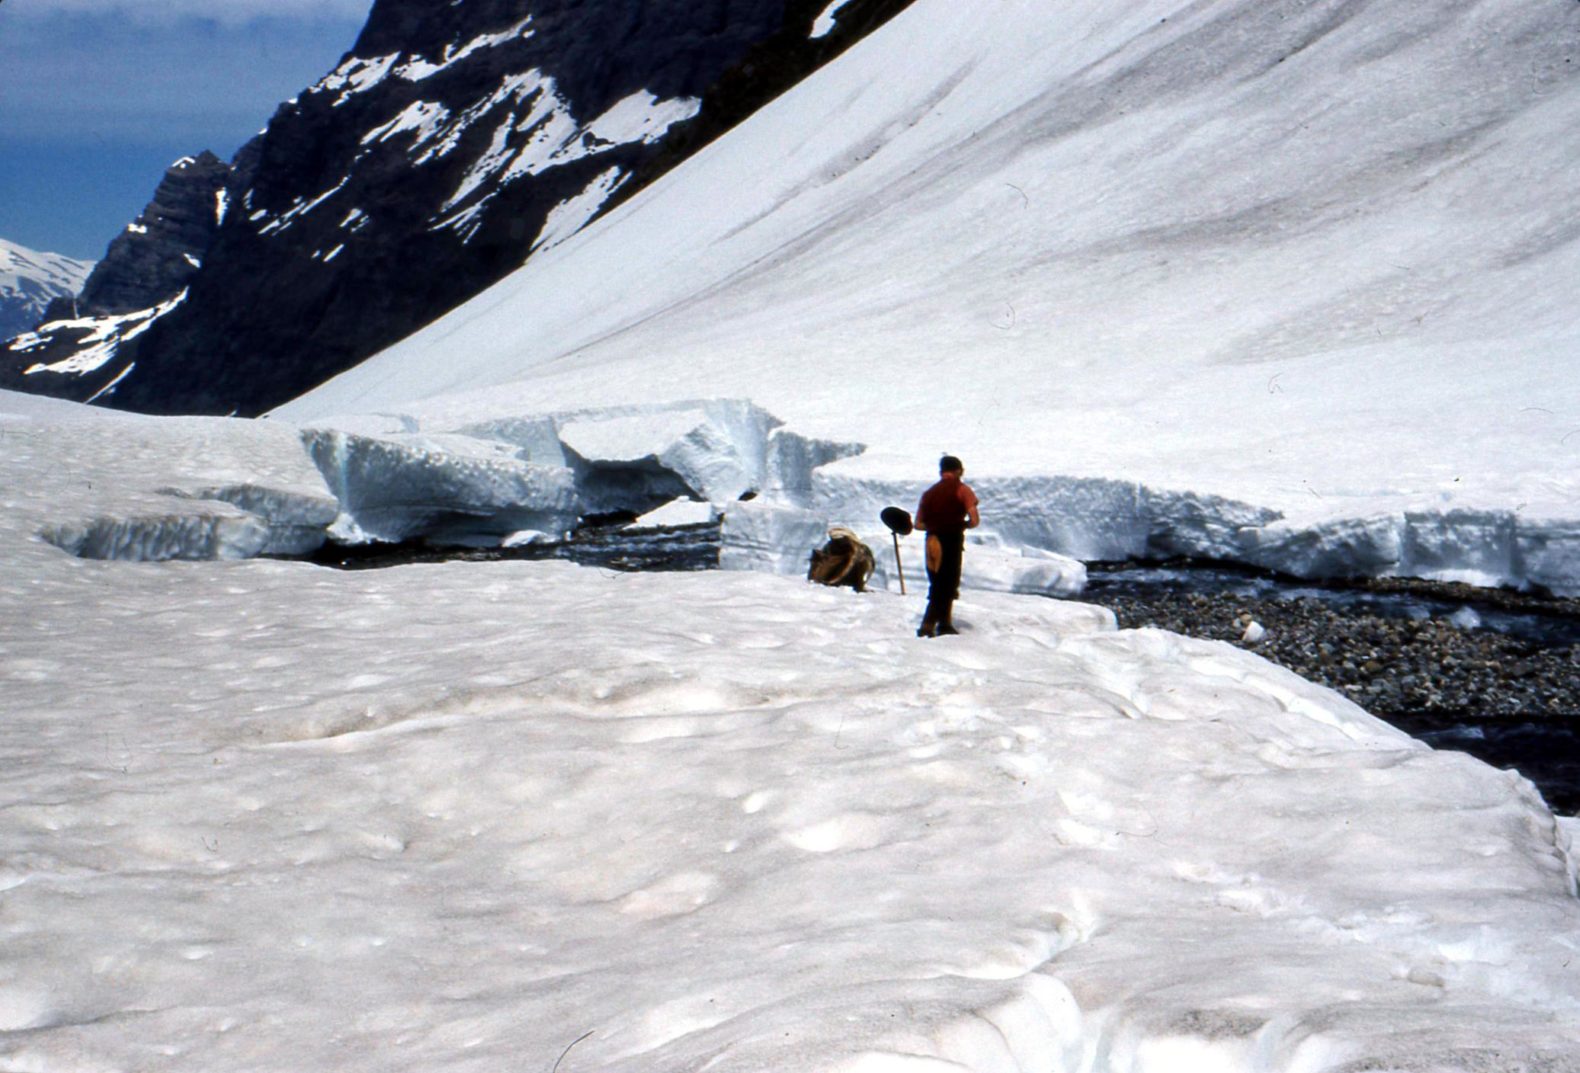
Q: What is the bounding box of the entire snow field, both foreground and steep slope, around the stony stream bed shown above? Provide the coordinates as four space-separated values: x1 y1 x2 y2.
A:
0 0 1580 1073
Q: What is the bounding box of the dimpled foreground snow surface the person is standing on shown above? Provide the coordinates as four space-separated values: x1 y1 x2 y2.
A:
0 395 1580 1073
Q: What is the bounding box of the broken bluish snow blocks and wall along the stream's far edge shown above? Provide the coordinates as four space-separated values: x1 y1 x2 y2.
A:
33 400 1580 596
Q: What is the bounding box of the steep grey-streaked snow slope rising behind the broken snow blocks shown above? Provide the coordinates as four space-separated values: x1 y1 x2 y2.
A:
281 0 1580 593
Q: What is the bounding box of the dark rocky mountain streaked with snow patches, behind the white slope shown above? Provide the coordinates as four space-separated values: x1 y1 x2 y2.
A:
0 0 910 414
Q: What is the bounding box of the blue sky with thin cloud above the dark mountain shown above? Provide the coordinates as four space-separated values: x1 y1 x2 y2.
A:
0 0 373 259
